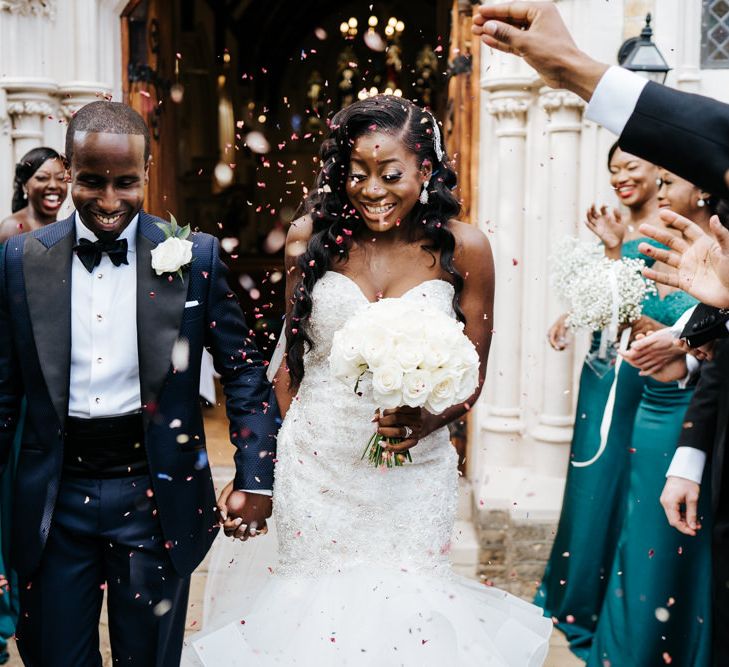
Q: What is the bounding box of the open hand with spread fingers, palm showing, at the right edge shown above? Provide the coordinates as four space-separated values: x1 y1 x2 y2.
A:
638 209 729 308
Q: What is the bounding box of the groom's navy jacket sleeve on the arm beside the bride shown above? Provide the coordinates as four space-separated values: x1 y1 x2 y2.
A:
205 237 281 491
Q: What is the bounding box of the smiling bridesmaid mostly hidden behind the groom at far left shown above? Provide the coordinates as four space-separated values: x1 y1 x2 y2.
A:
0 147 68 664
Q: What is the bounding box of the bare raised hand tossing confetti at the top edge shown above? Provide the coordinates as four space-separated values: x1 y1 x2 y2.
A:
472 2 607 100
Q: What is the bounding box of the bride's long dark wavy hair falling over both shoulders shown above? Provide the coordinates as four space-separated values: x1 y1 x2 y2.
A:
286 95 465 387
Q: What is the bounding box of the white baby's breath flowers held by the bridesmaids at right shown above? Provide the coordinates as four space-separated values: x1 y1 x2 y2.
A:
552 237 656 342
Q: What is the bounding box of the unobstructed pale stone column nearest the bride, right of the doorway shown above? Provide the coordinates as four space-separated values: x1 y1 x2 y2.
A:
479 87 532 469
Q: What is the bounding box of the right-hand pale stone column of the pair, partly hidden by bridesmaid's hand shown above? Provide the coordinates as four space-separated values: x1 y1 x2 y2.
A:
531 88 584 476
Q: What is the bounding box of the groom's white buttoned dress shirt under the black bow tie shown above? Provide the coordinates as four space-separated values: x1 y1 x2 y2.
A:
68 212 142 419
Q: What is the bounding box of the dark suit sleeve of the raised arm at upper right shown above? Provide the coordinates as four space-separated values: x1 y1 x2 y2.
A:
619 82 729 197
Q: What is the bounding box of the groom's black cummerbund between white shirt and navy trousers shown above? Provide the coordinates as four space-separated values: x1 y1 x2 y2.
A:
63 412 147 478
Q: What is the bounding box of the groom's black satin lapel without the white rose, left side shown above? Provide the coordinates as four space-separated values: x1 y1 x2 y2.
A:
23 215 76 424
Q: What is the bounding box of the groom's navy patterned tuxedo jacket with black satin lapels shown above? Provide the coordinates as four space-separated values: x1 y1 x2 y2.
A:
0 212 280 576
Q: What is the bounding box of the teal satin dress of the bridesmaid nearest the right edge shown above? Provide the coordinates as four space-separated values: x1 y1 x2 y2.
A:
587 292 711 667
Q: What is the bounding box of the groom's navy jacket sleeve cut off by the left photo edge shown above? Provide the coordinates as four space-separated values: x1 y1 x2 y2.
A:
0 244 22 472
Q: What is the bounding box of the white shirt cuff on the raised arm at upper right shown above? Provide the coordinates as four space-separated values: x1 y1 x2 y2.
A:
585 66 648 136
